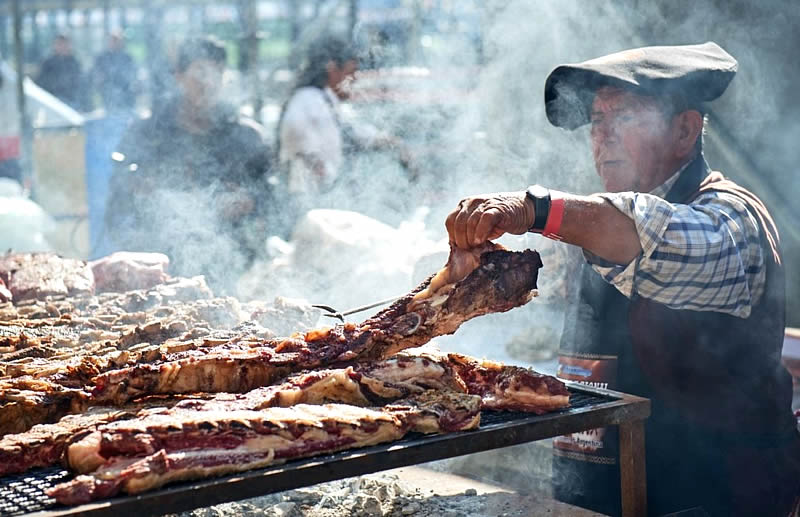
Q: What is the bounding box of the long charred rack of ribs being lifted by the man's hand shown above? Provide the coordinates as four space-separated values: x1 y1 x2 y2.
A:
92 245 542 404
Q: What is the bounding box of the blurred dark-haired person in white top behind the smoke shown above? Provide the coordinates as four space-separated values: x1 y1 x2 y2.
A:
278 35 416 207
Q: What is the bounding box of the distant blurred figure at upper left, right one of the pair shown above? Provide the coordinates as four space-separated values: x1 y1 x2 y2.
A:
90 32 138 112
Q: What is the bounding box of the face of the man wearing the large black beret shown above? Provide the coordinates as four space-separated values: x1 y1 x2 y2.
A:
591 87 674 192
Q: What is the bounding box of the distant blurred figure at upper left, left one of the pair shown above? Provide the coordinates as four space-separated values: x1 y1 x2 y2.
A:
36 34 87 111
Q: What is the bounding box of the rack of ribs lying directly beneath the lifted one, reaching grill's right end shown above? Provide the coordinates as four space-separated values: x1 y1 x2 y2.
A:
178 351 569 414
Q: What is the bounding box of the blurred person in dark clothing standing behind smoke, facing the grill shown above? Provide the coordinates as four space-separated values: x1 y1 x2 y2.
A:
105 37 272 294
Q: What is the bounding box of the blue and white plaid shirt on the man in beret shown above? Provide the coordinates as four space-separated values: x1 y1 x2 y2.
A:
584 160 766 318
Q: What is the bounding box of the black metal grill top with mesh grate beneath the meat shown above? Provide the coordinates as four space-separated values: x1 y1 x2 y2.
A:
0 386 646 517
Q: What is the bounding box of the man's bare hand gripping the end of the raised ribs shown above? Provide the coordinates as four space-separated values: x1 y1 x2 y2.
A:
445 191 535 249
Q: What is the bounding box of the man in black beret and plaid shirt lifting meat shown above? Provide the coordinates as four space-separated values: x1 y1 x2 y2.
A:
446 43 800 516
